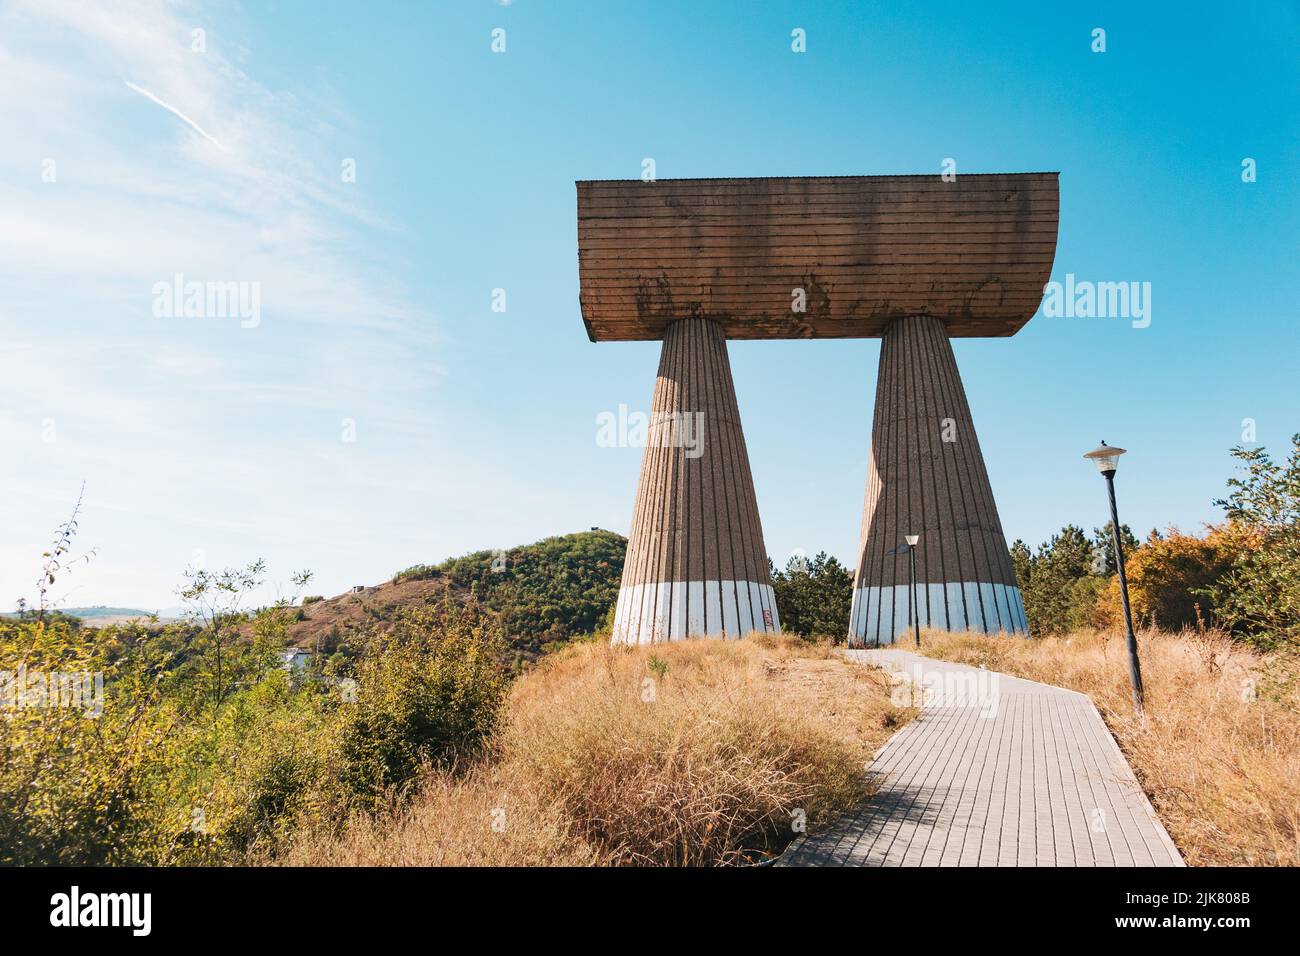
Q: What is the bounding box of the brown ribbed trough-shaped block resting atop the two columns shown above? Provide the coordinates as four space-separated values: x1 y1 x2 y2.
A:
577 173 1060 342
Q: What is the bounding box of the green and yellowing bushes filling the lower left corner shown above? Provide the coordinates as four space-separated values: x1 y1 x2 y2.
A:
0 582 506 865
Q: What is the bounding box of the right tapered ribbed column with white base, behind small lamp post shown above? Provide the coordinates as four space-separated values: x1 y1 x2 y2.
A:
849 316 1028 646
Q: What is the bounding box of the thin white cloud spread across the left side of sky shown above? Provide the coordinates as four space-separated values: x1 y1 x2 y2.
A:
0 0 441 606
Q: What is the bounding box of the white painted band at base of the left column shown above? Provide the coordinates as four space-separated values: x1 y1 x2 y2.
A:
612 581 781 644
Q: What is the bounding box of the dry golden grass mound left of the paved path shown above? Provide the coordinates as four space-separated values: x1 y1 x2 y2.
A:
287 637 913 865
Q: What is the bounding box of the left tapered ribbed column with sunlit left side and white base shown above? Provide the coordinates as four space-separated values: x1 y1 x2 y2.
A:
614 319 780 644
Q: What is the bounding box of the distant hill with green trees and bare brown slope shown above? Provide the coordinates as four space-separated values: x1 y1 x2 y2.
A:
289 529 628 659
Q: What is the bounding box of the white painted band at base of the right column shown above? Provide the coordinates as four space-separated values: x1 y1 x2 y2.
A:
849 581 1030 645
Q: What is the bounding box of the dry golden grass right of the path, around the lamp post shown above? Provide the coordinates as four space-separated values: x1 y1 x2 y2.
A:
922 631 1300 866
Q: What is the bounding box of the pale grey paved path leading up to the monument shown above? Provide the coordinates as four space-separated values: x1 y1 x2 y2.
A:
777 649 1184 866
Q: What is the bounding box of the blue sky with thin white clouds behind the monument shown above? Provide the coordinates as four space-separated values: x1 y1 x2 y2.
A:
0 0 1300 607
